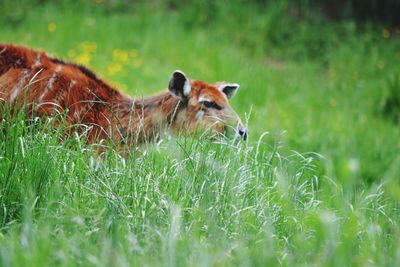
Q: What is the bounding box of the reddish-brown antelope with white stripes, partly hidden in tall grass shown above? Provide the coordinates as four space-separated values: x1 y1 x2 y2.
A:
0 44 247 145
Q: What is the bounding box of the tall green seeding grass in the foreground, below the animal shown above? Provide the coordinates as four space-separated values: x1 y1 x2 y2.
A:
0 106 398 266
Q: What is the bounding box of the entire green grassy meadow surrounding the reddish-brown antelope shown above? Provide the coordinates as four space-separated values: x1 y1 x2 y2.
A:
0 0 400 266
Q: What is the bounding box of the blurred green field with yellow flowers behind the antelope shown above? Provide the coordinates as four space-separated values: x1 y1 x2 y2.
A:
0 0 400 263
